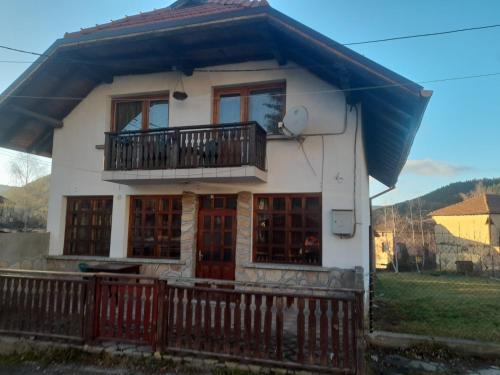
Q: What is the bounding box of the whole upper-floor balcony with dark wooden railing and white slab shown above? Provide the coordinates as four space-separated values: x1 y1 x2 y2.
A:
102 122 267 183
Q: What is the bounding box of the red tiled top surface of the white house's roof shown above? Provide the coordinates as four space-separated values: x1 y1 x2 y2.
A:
64 0 269 37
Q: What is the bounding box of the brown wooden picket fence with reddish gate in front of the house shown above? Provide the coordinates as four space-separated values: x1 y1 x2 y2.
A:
0 270 363 374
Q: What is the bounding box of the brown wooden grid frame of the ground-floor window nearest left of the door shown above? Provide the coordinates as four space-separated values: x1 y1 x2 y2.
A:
127 195 182 260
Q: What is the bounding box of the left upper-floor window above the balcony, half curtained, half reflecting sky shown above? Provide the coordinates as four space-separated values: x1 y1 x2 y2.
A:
112 94 169 132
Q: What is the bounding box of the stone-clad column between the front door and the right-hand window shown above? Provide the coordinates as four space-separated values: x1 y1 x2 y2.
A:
235 191 252 280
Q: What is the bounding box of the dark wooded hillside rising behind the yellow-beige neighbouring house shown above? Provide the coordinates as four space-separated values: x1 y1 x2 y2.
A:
374 178 500 223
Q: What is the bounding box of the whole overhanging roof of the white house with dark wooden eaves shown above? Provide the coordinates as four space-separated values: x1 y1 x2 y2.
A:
0 0 432 186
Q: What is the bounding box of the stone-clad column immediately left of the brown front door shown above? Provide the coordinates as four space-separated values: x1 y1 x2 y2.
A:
180 192 198 277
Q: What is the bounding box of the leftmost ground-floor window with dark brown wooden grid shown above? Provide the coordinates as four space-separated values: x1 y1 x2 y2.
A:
64 197 113 256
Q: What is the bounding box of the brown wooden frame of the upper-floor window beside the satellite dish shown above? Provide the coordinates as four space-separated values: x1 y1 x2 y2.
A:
212 81 286 126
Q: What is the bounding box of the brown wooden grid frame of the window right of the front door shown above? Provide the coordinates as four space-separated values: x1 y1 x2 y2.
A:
252 193 323 266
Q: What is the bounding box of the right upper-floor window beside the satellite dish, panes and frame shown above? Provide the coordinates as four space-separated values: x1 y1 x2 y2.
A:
213 82 286 134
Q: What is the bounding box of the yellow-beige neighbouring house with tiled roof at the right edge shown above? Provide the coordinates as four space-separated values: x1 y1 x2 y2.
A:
430 194 500 271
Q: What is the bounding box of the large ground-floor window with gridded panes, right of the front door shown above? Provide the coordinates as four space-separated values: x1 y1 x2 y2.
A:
253 194 321 265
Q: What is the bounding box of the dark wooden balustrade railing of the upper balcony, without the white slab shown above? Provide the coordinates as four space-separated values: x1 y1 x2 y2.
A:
105 122 266 171
